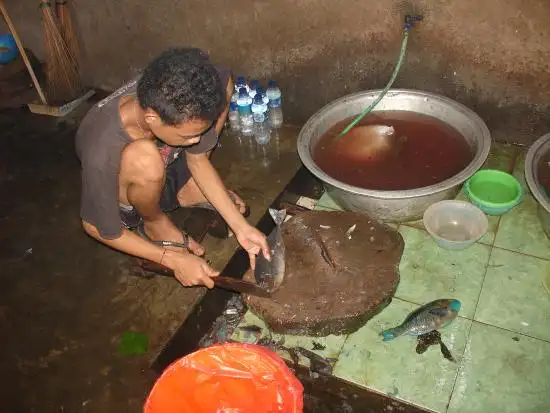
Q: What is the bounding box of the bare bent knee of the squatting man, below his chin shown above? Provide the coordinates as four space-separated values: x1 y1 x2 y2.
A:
120 140 166 183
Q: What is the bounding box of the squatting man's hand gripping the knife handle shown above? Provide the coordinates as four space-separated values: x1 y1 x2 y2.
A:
162 250 219 288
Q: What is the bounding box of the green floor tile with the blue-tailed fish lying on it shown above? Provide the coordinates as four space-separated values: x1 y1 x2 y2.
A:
334 299 471 412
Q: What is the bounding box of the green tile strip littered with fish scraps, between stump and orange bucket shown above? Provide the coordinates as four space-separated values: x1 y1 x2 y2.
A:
231 311 346 367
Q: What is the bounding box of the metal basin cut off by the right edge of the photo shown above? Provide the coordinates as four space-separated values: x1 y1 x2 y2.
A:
525 133 550 237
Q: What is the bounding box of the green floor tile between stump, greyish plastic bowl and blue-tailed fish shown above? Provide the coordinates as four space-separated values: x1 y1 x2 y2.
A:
396 226 490 317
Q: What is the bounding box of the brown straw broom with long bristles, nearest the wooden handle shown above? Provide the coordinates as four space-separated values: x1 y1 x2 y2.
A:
40 0 81 103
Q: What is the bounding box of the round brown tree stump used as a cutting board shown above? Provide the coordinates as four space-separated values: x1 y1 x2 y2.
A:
244 211 404 336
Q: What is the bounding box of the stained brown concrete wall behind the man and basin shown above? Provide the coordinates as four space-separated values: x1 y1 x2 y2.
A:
6 0 550 141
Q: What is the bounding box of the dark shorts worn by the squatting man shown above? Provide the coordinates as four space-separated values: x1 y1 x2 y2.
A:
120 154 191 229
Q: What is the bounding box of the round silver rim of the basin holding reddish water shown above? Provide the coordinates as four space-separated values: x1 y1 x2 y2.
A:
297 89 491 199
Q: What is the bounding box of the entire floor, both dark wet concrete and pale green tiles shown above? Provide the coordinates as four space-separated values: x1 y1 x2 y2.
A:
4 98 550 413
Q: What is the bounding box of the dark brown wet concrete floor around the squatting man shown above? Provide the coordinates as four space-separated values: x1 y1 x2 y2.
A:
0 103 298 413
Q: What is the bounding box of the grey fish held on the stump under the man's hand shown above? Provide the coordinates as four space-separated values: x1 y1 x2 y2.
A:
254 208 286 292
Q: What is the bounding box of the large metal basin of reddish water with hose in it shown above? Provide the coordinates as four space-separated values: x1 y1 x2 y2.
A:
298 89 491 222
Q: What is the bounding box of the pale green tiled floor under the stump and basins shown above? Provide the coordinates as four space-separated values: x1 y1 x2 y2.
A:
232 144 550 413
